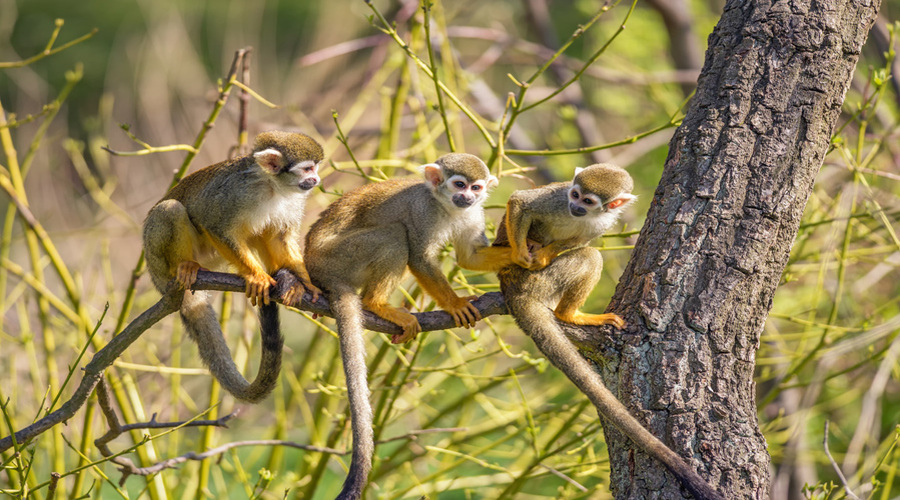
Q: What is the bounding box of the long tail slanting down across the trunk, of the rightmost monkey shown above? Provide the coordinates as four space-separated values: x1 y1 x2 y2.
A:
506 295 724 500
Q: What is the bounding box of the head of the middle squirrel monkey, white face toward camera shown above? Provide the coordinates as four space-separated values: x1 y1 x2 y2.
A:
422 153 497 209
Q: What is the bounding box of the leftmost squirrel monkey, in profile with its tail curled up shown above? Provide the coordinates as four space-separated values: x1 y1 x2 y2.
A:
144 131 323 403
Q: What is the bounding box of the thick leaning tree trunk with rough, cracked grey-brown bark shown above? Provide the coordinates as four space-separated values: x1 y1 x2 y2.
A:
597 0 880 499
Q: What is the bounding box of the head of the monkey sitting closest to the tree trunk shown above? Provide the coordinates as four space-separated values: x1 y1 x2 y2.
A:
569 163 637 217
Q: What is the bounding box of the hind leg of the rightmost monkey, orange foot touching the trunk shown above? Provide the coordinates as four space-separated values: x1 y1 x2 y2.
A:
553 248 625 328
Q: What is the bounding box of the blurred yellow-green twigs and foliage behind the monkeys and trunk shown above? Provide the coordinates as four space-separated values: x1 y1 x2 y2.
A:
0 0 900 499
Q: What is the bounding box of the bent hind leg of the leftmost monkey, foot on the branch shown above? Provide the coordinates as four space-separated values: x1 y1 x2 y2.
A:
144 200 200 292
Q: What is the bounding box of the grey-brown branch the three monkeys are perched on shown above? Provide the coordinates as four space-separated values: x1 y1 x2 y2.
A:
0 271 520 452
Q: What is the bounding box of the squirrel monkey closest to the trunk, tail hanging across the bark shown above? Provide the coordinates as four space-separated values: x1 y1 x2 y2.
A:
494 163 722 499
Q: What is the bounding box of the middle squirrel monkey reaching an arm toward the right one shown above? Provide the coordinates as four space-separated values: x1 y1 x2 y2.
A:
306 153 512 500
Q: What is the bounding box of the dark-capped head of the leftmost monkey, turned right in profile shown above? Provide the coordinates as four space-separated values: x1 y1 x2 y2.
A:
253 130 325 191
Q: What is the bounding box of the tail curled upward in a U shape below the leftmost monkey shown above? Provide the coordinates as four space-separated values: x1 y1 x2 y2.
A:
181 292 284 403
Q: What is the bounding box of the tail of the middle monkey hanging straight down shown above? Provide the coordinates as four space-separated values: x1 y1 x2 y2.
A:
329 290 375 500
